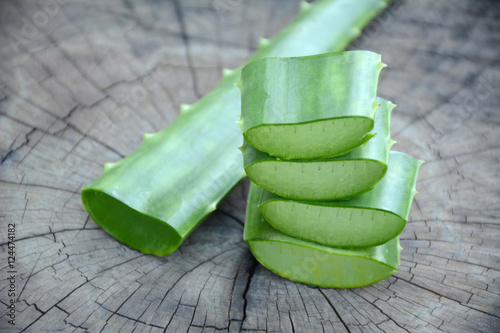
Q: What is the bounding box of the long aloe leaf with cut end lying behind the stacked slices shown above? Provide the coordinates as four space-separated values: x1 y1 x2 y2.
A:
82 0 390 255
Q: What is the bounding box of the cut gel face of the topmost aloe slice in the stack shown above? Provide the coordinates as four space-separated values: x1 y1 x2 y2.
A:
244 117 373 159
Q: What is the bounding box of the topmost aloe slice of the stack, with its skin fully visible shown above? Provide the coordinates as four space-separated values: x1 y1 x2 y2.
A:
238 51 385 159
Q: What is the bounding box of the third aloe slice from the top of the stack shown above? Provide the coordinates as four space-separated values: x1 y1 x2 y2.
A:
259 151 423 248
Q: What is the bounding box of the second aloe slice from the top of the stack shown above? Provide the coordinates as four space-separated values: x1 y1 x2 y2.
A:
241 98 395 200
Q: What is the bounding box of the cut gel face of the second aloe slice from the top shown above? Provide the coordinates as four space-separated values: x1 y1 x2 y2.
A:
245 159 387 200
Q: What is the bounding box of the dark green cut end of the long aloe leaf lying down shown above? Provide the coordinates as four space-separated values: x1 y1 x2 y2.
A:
82 189 182 256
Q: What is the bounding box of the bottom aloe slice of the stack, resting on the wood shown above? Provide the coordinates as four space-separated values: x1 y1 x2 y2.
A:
244 184 401 288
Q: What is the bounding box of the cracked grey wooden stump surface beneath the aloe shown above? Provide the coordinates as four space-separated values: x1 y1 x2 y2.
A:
0 0 500 332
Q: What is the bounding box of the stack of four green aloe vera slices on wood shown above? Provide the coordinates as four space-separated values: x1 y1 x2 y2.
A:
237 51 422 288
